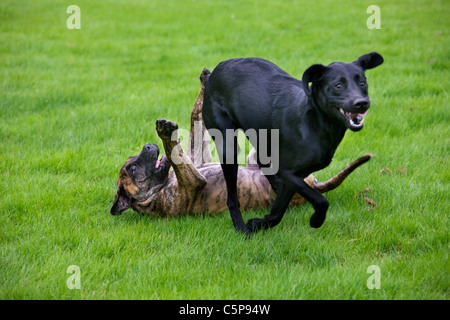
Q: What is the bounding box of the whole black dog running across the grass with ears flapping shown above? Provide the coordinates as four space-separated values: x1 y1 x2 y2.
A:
203 52 383 234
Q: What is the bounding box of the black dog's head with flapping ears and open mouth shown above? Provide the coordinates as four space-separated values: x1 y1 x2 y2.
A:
302 52 384 131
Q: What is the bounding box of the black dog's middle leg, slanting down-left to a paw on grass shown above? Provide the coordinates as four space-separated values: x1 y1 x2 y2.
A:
247 182 295 232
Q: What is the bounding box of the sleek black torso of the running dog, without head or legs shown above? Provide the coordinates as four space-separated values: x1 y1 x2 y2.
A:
203 58 330 178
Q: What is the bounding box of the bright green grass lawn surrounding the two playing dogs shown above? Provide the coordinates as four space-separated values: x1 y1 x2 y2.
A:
0 0 450 299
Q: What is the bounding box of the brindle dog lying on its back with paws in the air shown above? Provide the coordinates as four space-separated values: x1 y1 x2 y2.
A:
111 69 371 216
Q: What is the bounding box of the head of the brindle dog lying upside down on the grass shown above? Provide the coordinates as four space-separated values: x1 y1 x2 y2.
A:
111 144 170 215
